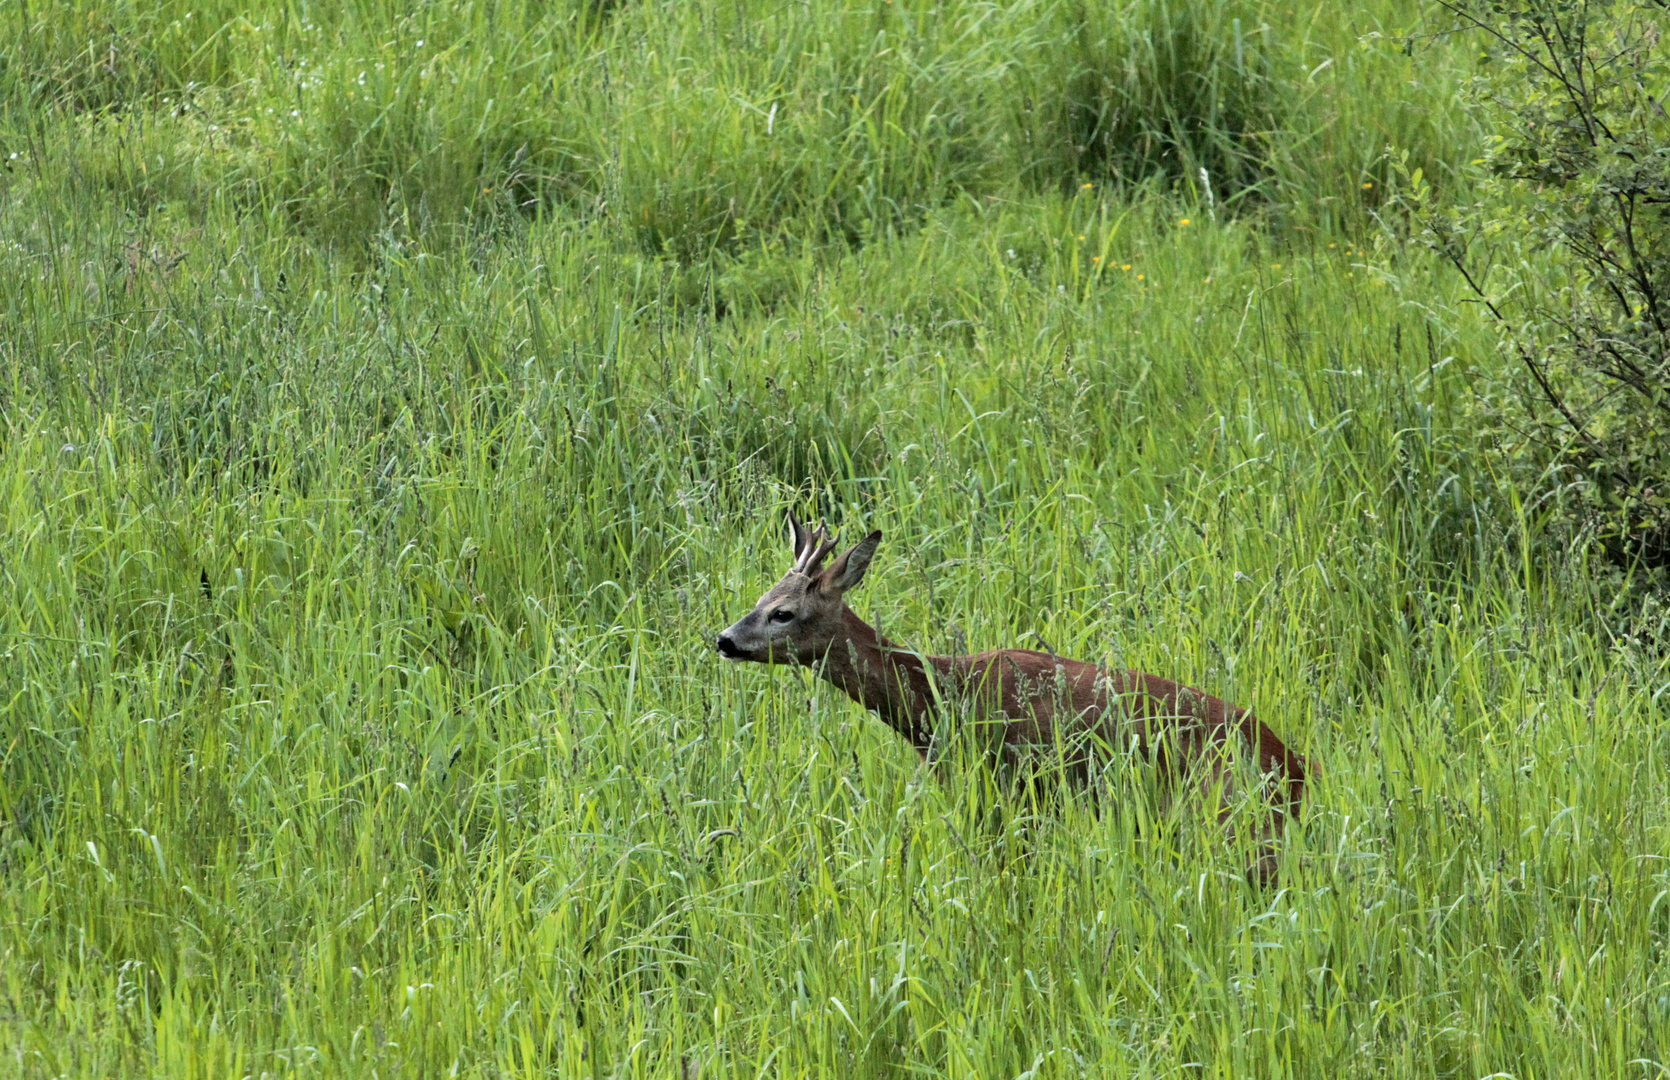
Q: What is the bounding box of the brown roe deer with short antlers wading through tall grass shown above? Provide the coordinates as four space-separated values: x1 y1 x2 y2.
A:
716 512 1304 885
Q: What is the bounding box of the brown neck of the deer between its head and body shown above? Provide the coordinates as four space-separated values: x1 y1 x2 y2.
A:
823 608 954 753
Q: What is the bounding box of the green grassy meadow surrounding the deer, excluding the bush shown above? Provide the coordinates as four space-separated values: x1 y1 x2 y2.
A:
0 0 1670 1080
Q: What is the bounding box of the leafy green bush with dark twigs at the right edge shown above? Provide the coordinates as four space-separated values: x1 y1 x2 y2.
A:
1411 0 1670 569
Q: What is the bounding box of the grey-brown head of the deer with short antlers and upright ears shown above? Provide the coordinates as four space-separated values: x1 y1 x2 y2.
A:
718 511 882 664
